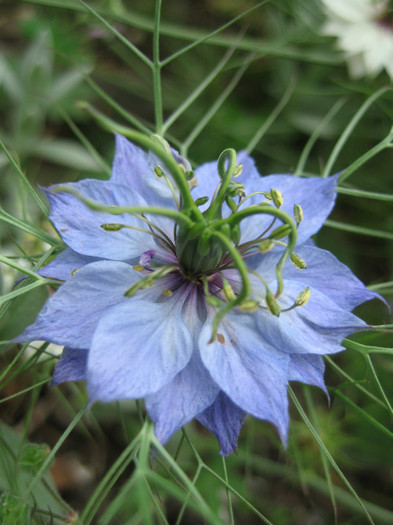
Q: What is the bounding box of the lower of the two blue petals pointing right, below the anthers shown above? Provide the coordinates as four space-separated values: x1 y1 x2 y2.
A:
254 280 367 355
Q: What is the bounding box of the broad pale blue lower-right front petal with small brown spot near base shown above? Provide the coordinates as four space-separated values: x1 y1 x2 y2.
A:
199 314 289 443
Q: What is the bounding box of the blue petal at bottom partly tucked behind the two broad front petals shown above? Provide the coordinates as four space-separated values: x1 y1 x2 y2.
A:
145 352 219 443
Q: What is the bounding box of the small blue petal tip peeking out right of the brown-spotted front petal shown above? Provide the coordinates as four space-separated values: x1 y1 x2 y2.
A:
288 354 327 394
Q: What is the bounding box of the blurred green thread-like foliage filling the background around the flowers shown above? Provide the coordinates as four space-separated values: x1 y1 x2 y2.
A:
0 0 393 525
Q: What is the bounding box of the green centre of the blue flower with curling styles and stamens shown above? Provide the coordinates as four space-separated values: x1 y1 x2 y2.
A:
57 132 310 340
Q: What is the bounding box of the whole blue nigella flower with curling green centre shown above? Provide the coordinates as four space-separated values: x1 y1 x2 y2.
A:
18 136 375 454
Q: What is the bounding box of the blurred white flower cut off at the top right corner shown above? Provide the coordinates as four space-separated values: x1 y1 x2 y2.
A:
322 0 393 79
